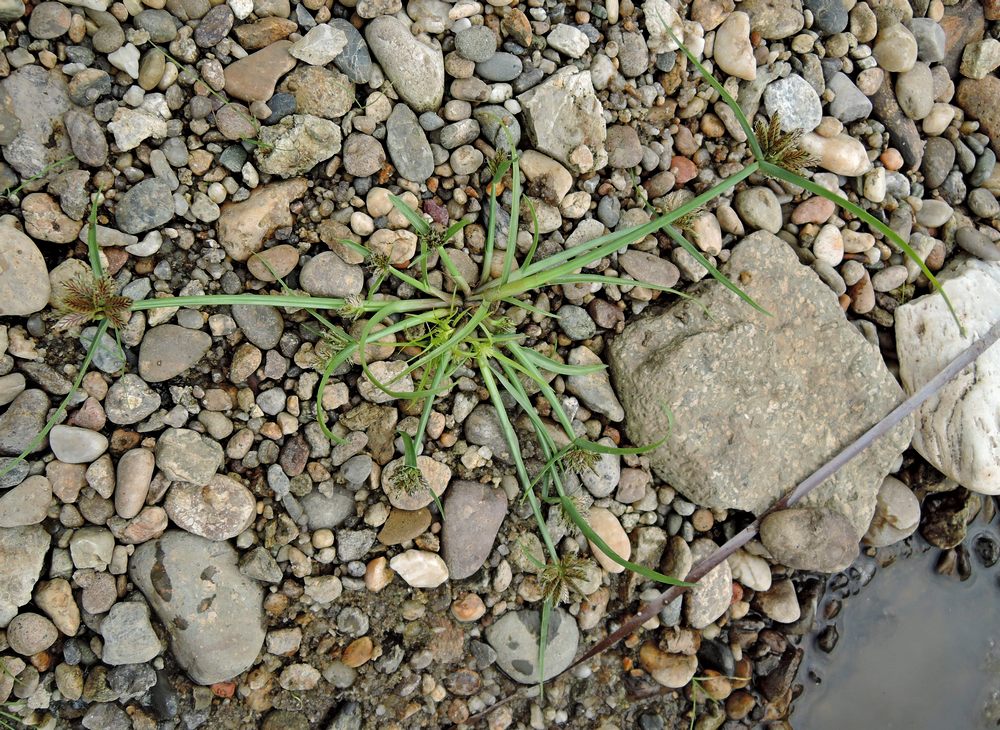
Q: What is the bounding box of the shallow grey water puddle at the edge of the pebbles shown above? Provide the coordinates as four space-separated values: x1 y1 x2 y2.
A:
791 521 1000 730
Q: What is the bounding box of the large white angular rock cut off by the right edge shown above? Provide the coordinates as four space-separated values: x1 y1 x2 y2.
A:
896 259 1000 494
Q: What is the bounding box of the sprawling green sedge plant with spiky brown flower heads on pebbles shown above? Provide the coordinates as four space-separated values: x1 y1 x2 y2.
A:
0 24 968 686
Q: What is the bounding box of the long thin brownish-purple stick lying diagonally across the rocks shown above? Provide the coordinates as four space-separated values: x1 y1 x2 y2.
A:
468 322 1000 723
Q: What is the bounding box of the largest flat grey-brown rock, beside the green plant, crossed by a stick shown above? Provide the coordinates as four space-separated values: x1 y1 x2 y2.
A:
609 231 913 539
